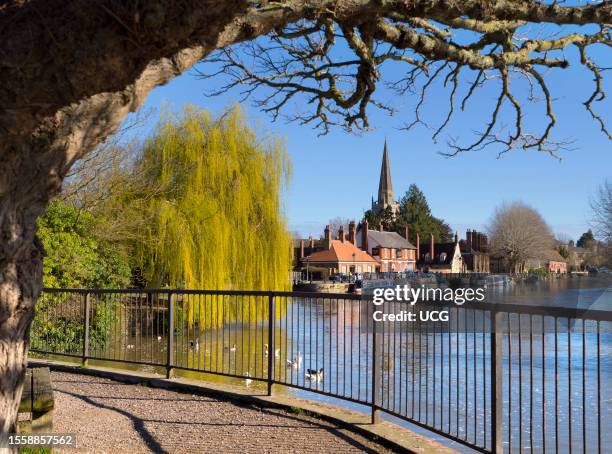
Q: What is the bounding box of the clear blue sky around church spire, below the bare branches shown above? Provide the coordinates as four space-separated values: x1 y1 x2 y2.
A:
118 40 612 243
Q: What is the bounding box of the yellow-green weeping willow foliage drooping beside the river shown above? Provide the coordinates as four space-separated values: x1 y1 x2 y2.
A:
137 107 292 325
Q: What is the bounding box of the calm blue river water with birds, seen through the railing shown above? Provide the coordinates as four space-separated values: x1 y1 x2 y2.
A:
40 278 612 452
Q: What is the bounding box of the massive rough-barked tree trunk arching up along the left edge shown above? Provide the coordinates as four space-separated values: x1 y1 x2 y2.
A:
0 0 256 433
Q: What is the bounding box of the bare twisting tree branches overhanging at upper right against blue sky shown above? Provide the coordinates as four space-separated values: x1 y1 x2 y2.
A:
199 0 612 156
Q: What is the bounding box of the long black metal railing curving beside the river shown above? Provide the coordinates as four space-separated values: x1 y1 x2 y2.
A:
31 289 612 452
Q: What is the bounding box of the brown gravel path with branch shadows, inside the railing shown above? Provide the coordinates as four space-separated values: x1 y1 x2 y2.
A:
51 372 396 454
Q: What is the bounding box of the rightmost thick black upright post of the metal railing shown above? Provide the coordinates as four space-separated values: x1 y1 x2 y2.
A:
490 311 510 454
